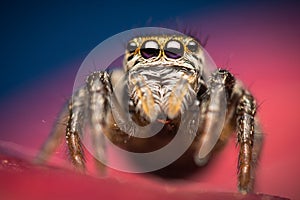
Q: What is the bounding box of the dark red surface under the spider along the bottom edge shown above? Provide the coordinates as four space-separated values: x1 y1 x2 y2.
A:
0 155 288 200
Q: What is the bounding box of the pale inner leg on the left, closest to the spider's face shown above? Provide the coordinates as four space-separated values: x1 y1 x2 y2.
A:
87 72 112 172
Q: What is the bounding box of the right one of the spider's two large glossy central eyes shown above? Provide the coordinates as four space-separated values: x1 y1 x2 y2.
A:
164 40 184 59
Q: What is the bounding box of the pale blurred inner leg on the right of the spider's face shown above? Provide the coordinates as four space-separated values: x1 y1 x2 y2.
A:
195 69 234 166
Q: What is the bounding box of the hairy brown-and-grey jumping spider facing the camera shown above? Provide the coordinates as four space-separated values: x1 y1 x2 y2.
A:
38 34 263 194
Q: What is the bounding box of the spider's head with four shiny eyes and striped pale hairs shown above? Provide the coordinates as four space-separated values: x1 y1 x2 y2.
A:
124 35 204 122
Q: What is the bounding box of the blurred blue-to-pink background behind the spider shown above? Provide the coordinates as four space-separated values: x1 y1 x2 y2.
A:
0 0 300 199
